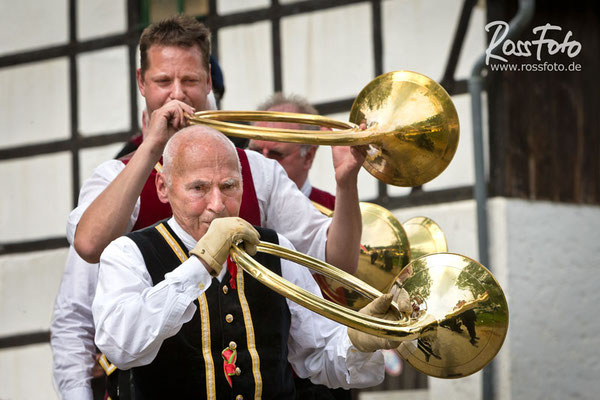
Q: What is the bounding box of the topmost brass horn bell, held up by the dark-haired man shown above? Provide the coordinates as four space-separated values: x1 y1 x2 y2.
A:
350 71 459 187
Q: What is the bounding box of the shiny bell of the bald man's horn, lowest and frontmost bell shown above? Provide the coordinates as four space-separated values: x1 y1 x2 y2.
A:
396 253 508 378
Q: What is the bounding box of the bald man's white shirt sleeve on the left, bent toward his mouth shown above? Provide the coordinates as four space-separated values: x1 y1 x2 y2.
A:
92 237 212 369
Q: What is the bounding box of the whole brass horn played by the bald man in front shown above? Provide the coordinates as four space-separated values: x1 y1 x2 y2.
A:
231 242 508 378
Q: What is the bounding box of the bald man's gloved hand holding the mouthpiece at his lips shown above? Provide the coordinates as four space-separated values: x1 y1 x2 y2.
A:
190 217 260 276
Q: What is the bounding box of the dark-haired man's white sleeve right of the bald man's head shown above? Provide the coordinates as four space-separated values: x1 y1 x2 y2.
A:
246 150 331 261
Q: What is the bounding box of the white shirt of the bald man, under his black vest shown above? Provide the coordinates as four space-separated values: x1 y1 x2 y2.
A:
92 218 384 388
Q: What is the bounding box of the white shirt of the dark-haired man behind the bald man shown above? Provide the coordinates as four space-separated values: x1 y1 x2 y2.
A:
50 151 338 399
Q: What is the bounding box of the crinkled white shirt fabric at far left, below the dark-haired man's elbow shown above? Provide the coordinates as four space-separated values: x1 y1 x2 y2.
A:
50 247 98 400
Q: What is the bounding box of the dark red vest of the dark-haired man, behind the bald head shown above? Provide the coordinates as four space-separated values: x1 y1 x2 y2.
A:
121 148 260 231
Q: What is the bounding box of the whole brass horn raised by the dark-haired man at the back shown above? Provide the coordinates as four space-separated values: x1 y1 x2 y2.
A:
188 71 459 187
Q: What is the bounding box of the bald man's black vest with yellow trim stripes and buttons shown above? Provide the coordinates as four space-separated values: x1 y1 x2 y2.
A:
127 221 295 399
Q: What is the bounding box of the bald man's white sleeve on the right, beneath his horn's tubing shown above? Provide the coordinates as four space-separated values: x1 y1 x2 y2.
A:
279 235 385 389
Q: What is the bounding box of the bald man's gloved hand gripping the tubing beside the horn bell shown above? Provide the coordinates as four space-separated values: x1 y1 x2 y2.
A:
348 285 412 353
